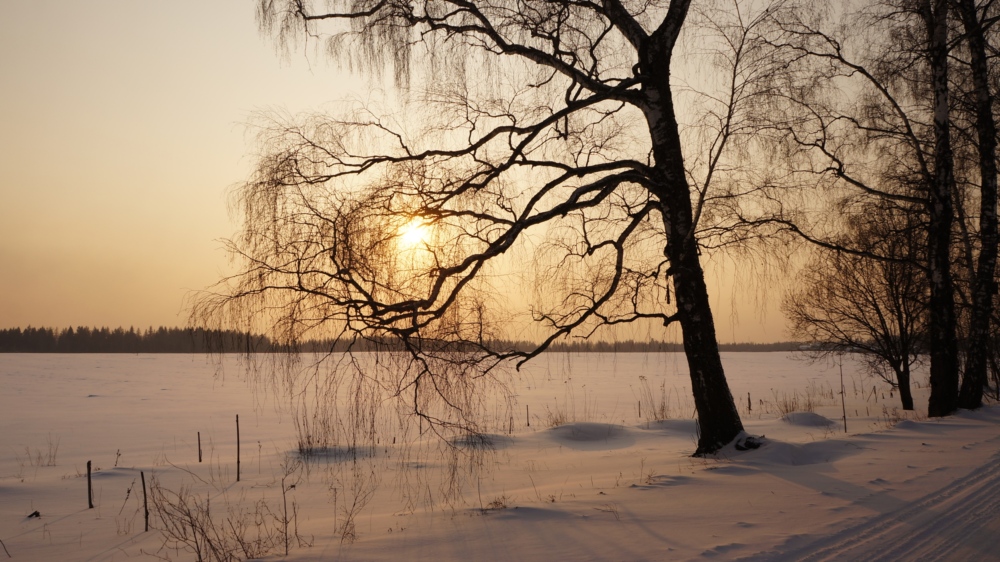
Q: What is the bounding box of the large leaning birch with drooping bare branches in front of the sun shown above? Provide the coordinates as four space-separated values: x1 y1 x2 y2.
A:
195 0 780 454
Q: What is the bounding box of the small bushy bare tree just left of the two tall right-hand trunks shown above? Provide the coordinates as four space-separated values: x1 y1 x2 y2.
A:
783 201 927 410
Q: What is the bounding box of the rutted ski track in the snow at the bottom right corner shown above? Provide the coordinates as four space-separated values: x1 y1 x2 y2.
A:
746 444 1000 562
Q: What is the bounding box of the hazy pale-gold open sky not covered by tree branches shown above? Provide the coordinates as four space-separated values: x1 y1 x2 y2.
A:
0 0 787 341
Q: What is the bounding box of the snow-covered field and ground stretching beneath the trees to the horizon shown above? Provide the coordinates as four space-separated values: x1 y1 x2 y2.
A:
0 353 1000 561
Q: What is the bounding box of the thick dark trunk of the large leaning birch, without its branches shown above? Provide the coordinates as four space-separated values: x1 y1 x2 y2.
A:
641 7 743 456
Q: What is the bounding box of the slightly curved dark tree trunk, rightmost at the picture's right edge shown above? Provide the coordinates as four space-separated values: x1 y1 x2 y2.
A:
958 0 997 410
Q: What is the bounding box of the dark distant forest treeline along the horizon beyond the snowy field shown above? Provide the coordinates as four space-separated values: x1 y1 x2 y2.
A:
0 326 801 353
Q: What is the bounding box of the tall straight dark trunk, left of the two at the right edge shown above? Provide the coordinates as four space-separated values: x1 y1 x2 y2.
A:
921 0 958 417
